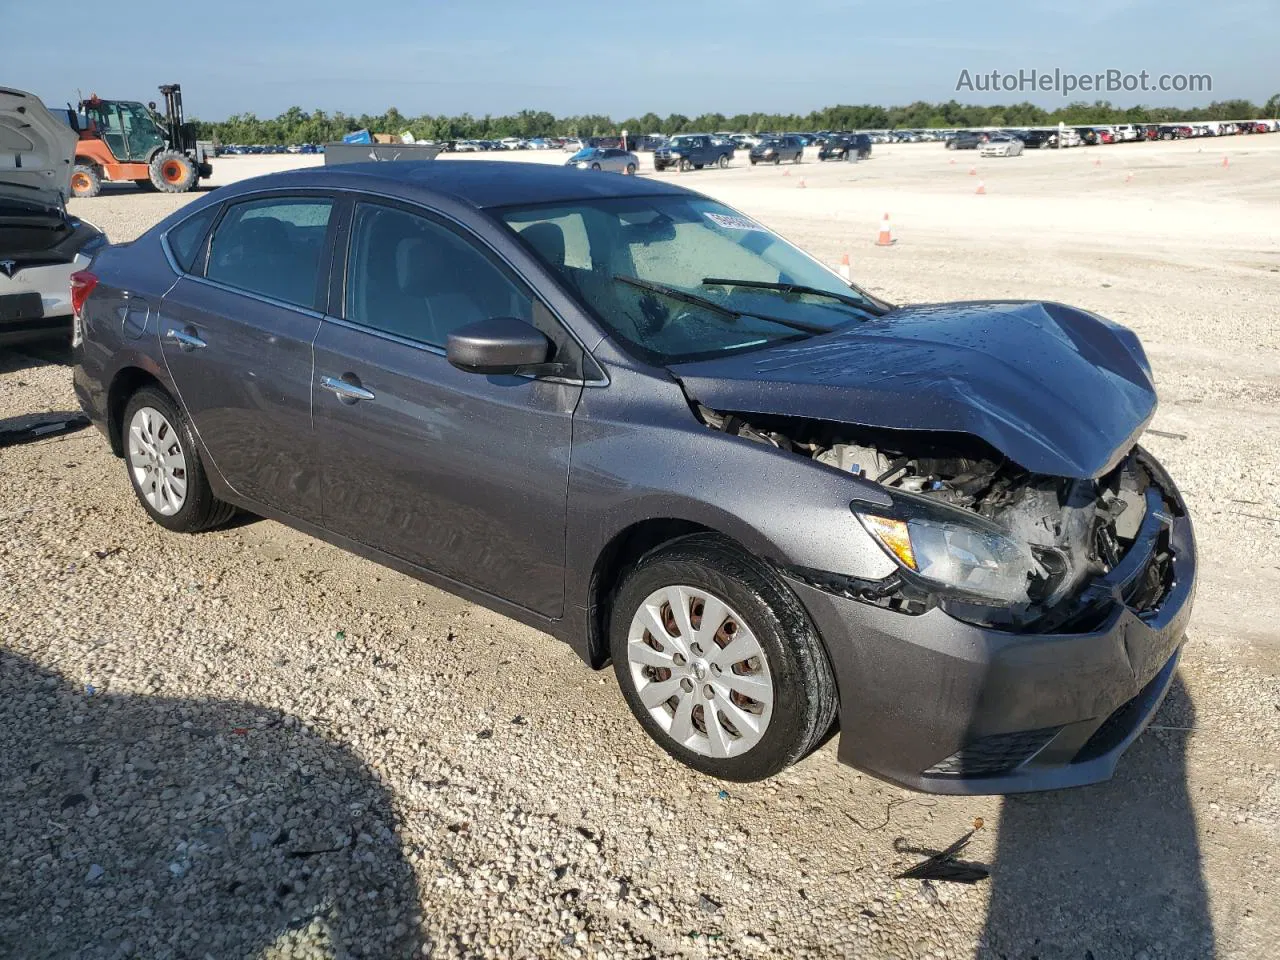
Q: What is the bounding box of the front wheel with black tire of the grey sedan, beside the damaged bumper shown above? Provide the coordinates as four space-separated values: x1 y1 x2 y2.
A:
611 534 837 781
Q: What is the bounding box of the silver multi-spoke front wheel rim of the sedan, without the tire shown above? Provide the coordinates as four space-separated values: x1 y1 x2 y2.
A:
627 585 773 758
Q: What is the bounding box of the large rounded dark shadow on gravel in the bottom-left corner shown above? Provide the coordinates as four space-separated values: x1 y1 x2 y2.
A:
0 648 422 960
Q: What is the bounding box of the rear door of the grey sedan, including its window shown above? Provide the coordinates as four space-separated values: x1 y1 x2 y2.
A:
159 192 337 521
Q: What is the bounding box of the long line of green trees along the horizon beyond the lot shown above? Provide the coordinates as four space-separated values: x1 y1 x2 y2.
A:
195 93 1280 143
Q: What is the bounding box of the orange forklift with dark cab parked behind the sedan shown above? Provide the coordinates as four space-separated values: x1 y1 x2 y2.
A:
70 83 214 197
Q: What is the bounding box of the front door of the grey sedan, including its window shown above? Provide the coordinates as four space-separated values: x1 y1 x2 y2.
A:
315 204 582 617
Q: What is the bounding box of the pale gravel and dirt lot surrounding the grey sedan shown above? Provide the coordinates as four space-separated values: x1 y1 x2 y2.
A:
0 142 1280 960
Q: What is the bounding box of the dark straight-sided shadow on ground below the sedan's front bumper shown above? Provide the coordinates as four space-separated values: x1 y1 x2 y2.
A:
977 678 1215 960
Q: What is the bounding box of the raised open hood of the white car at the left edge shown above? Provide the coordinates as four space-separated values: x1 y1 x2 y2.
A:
0 87 79 206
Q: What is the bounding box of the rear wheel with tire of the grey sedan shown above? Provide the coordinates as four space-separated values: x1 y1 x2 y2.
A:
123 387 236 534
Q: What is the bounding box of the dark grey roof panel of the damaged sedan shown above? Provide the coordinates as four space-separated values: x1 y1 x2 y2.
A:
219 160 692 209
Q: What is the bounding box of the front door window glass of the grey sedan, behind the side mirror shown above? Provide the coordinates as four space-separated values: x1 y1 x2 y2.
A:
346 204 534 347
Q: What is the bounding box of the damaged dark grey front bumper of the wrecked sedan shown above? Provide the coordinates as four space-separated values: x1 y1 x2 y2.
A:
790 471 1196 794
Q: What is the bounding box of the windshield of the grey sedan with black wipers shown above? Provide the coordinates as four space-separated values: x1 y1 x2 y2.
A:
498 196 879 365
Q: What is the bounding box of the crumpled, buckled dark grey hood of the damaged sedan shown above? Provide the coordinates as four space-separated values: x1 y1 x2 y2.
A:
671 301 1156 479
